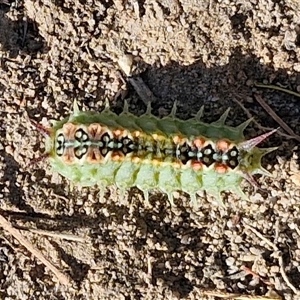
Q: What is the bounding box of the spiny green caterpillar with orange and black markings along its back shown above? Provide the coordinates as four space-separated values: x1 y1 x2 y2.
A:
34 101 276 205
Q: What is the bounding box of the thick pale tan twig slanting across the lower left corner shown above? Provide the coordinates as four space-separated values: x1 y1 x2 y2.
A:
0 215 71 286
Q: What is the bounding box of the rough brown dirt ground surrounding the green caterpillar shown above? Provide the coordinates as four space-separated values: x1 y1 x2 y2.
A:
0 0 300 299
